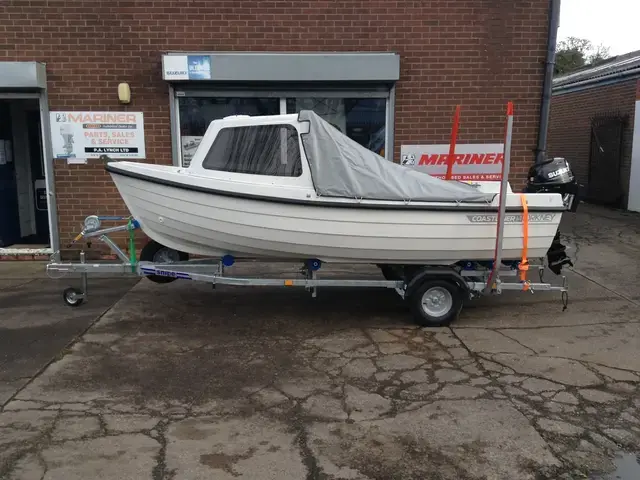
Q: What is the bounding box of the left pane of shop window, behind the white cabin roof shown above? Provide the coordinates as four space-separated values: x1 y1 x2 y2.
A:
178 97 280 167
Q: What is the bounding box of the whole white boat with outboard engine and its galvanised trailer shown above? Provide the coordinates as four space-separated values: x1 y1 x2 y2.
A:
47 111 578 326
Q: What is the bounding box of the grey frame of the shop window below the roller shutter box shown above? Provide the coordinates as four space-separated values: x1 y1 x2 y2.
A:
169 83 395 167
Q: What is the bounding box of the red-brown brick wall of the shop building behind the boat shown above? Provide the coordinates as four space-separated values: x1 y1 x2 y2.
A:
0 0 549 256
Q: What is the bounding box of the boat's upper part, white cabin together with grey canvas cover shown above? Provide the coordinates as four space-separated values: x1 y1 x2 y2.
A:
184 110 498 203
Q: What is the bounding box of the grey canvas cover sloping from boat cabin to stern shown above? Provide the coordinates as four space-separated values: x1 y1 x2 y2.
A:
298 110 495 203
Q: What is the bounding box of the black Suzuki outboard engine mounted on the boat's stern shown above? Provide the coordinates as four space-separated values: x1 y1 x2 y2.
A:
524 157 580 275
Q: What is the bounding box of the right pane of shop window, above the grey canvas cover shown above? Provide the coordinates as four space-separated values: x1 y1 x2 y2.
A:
287 97 386 157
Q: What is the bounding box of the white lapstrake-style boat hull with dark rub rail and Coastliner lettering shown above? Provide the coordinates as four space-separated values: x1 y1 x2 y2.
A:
107 162 563 264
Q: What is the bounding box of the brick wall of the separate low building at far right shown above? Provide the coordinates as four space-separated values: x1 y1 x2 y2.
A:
547 79 637 206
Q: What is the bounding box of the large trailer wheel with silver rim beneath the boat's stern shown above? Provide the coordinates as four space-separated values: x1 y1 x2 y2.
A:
408 280 463 327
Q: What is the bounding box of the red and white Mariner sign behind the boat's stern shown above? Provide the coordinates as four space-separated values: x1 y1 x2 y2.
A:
400 143 504 181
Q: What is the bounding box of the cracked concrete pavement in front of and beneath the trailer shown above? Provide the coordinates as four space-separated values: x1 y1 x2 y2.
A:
0 203 640 480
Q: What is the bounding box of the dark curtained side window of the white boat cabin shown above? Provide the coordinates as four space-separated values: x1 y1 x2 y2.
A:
202 125 302 177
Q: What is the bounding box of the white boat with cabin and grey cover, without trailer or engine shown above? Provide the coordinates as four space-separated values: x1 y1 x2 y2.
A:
106 111 566 265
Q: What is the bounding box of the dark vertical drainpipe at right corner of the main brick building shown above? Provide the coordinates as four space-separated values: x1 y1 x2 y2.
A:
536 0 561 163
